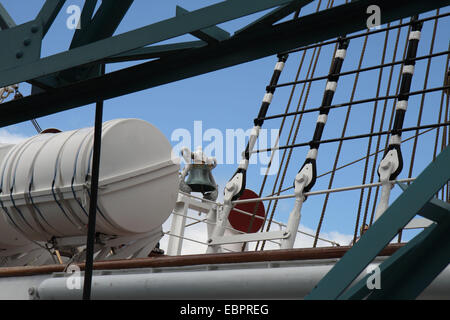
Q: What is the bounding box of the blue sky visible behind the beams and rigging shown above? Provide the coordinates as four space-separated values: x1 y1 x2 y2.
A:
1 0 450 250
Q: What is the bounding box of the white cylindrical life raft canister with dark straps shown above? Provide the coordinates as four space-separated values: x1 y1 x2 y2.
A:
0 119 179 248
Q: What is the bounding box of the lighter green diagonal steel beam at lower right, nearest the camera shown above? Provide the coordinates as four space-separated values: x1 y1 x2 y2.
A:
306 146 450 300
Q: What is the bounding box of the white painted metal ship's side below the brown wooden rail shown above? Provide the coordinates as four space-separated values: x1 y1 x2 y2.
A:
27 257 450 300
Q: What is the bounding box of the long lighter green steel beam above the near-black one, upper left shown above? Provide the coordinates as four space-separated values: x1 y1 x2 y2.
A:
0 0 293 87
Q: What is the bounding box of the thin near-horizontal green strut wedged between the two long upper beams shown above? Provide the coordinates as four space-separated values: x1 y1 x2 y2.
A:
102 40 207 63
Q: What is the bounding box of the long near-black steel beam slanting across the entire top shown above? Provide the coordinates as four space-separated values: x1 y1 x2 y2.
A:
0 0 450 127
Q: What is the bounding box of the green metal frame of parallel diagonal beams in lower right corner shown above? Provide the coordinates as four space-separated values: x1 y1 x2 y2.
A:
306 146 450 300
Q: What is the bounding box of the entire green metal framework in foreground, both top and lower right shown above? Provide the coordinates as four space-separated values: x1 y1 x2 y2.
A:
0 0 450 299
